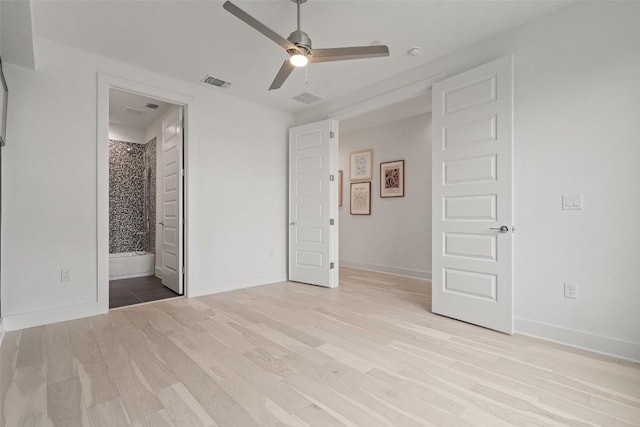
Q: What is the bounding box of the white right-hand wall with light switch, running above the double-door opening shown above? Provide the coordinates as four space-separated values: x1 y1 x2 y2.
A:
297 2 640 360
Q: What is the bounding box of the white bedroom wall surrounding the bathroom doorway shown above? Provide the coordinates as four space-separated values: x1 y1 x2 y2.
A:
2 39 293 328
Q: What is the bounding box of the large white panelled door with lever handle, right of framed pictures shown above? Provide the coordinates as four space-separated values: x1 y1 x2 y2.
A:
432 57 513 333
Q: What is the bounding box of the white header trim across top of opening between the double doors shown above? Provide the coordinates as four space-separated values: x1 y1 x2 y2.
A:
327 73 444 120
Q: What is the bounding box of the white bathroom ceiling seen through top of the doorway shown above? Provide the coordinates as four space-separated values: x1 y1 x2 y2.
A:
109 89 171 129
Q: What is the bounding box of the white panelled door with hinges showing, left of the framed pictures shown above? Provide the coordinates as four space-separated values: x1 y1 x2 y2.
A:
289 120 338 288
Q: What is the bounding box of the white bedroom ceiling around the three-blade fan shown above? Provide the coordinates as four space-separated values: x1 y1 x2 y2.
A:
32 0 568 112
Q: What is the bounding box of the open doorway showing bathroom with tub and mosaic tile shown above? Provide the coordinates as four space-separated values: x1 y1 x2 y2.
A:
109 88 184 309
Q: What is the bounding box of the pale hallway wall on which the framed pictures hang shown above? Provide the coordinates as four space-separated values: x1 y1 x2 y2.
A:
339 114 431 279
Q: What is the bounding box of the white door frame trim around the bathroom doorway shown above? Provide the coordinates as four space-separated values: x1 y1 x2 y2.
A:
96 73 192 313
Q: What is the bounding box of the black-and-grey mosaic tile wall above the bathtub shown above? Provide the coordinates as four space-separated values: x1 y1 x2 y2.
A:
109 139 156 253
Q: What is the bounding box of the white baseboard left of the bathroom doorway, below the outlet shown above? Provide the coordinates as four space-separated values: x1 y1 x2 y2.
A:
2 302 108 331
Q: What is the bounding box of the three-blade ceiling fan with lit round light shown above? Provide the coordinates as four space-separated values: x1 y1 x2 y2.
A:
223 0 389 90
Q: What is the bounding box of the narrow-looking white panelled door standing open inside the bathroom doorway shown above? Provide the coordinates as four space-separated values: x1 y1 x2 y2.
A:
160 107 183 294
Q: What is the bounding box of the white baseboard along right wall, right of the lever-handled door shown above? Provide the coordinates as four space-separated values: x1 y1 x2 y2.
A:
515 318 640 362
